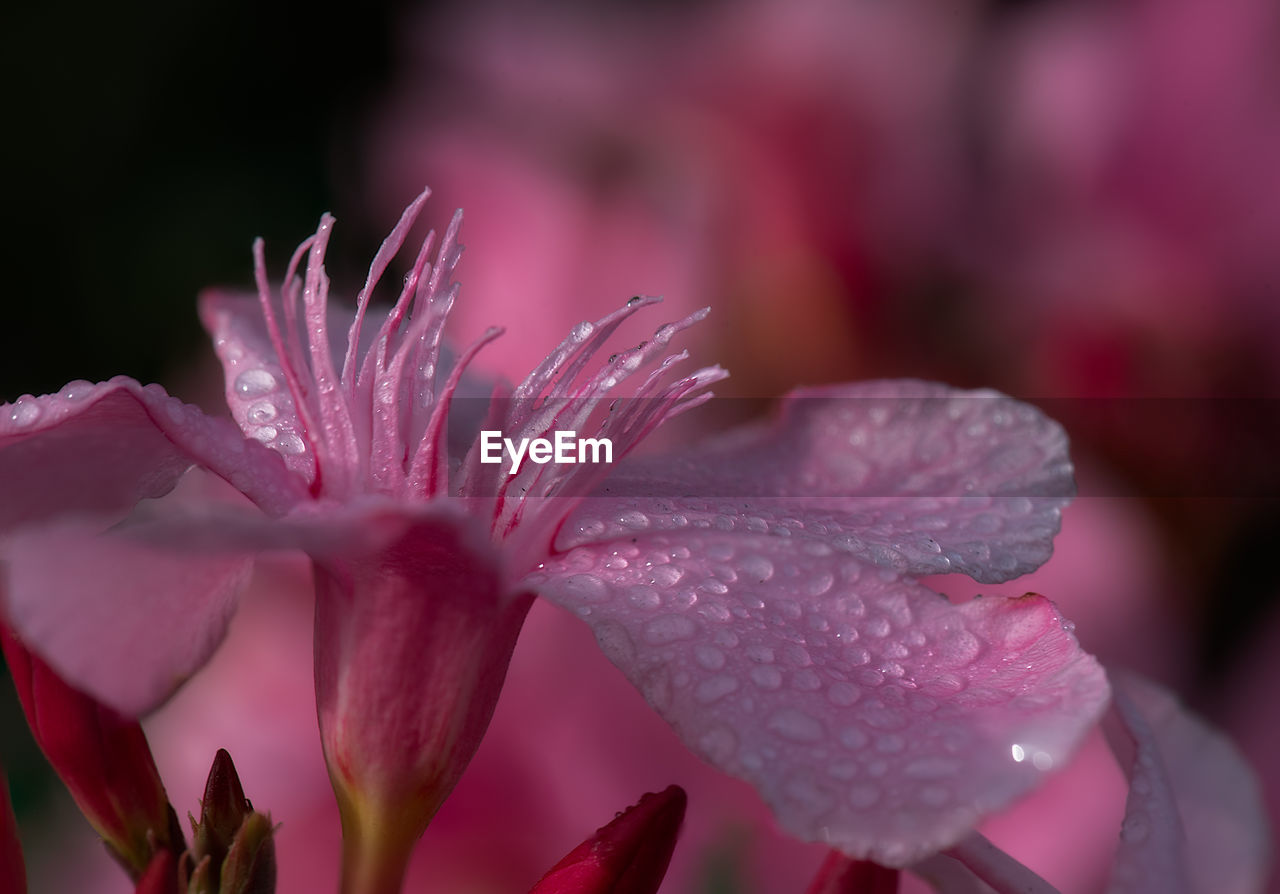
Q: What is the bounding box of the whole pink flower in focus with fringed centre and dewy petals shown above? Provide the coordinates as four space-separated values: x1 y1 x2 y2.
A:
0 193 1107 891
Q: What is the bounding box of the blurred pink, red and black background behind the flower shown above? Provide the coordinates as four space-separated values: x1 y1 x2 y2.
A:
0 0 1280 894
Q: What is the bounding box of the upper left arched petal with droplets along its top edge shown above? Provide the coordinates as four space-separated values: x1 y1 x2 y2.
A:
0 378 306 520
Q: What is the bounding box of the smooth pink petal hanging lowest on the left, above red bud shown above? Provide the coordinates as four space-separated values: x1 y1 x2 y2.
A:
3 521 250 717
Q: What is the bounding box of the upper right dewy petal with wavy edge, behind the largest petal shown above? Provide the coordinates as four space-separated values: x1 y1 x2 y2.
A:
557 382 1074 583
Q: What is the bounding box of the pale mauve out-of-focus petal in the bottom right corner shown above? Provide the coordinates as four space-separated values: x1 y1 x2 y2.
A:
1107 674 1271 894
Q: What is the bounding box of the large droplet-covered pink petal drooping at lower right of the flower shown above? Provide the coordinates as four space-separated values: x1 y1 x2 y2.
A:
526 532 1107 866
